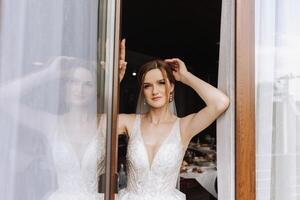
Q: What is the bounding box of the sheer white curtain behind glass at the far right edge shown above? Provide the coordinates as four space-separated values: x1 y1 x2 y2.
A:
255 0 300 200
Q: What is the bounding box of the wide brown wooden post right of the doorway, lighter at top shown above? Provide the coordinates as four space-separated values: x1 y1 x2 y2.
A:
235 0 256 200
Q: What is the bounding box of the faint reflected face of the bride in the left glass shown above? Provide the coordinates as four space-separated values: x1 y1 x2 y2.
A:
66 67 96 106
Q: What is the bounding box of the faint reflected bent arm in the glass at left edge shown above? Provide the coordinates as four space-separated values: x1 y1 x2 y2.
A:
0 57 71 133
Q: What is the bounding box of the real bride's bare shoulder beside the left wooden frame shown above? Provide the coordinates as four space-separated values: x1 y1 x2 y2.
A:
118 114 136 136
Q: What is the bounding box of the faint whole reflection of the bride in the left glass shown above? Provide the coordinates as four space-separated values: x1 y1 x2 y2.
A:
0 54 116 200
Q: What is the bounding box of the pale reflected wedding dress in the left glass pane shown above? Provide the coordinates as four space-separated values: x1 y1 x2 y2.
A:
44 116 106 200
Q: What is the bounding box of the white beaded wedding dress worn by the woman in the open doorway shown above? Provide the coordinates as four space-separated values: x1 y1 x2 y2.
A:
118 115 186 200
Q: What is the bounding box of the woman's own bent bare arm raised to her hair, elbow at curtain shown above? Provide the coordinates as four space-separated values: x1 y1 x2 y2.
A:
165 58 229 145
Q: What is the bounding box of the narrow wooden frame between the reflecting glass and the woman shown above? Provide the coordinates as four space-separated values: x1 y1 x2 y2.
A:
104 0 121 200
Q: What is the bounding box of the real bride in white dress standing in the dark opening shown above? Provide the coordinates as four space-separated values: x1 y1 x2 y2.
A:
118 45 229 200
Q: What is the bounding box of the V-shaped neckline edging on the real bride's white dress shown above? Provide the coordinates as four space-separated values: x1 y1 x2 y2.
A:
138 116 178 171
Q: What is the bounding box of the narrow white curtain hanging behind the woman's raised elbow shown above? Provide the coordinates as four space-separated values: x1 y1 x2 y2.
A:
217 0 235 200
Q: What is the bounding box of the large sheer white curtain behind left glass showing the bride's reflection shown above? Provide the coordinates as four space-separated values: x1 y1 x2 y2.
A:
0 0 101 200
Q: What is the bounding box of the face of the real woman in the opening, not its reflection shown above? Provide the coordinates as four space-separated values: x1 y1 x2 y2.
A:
142 69 173 108
